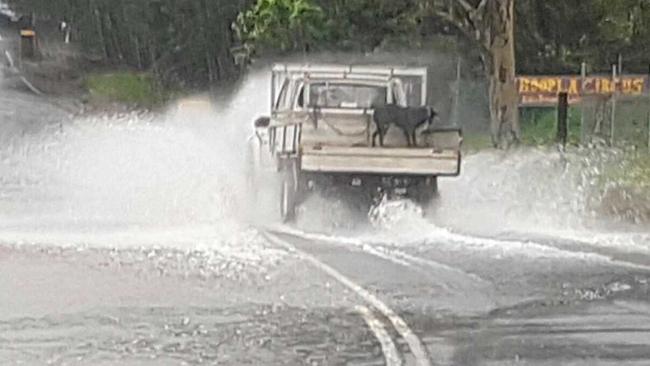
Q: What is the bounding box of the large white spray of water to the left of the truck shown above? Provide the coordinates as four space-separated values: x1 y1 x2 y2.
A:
0 72 286 270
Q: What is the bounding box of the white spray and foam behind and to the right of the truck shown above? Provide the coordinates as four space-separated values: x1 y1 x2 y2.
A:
286 143 650 261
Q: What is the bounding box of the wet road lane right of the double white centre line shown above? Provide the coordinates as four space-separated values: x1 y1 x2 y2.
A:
262 227 650 365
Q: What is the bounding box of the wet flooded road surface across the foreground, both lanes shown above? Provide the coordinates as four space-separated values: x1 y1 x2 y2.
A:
0 224 650 365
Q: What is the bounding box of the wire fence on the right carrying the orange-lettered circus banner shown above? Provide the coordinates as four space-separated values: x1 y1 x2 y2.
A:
517 71 650 151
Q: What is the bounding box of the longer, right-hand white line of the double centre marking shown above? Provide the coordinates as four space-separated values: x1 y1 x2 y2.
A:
263 232 431 366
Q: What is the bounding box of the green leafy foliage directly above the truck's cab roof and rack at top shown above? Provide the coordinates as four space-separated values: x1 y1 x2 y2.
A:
237 0 422 52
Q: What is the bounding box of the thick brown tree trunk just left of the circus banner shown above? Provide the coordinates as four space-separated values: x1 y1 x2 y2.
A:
486 0 520 148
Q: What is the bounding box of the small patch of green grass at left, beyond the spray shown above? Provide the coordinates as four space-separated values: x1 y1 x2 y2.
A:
85 71 166 107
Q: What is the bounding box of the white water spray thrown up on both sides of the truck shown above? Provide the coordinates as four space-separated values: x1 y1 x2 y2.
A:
0 55 644 264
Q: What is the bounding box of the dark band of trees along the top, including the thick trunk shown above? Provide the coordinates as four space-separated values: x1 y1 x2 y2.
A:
4 0 650 145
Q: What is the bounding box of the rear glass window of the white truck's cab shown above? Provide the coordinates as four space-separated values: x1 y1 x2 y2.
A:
309 82 387 108
